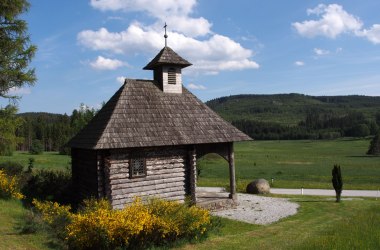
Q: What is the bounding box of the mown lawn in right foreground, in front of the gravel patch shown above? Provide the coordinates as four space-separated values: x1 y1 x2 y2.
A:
184 197 380 249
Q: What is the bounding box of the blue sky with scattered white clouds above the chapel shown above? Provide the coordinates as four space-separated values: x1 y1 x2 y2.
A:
0 0 380 114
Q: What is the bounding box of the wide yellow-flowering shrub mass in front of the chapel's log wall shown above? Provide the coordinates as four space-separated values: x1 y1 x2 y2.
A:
33 198 211 249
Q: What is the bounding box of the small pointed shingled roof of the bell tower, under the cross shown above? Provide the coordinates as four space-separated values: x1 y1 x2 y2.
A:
143 47 192 70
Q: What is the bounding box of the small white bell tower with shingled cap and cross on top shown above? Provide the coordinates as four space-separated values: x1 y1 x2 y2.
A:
143 23 192 94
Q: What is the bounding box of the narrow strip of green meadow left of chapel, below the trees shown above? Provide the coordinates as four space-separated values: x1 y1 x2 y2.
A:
0 151 71 170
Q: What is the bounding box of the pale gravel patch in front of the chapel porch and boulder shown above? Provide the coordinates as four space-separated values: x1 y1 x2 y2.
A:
212 194 299 225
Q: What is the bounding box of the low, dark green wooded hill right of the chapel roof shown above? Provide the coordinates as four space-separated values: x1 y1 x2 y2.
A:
206 94 380 139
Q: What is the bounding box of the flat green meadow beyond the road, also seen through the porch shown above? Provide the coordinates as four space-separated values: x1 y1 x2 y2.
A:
198 139 380 191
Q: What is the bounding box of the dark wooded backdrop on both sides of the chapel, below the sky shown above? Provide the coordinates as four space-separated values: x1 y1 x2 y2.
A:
0 94 380 154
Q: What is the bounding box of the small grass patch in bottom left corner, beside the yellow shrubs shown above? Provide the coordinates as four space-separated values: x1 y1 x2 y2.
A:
0 199 50 249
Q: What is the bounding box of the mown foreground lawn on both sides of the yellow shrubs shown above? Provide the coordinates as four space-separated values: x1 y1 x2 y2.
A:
0 196 380 249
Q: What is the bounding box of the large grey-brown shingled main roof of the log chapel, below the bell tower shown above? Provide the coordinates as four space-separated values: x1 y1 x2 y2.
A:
68 79 252 149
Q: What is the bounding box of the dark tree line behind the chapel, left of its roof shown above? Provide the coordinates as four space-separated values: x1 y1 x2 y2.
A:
0 104 97 155
